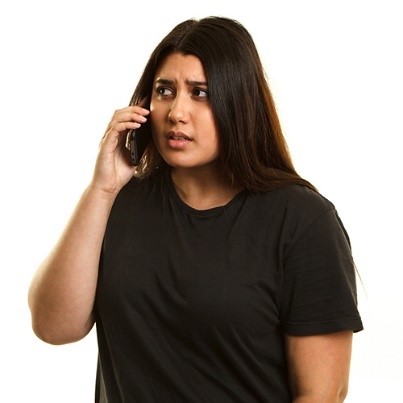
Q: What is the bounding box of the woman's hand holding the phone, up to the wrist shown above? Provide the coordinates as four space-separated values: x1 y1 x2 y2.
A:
91 105 150 195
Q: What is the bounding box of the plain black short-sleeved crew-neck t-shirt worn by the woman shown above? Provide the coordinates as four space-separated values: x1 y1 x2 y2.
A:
95 176 362 403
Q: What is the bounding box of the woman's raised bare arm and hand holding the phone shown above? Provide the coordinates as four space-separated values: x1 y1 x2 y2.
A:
28 106 149 344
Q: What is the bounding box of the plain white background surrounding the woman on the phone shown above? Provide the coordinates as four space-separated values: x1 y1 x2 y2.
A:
0 0 403 403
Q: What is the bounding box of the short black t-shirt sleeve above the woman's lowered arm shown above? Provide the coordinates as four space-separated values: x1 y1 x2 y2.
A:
279 208 363 336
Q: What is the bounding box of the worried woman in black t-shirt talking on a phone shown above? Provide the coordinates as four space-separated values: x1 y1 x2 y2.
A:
29 17 362 403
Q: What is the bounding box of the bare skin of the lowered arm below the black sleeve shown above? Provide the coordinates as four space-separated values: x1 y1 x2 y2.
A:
285 331 353 403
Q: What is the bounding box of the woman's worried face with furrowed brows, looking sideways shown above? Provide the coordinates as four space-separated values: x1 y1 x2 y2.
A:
150 53 218 168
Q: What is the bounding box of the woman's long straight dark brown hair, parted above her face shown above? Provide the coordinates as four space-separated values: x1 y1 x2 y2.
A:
131 17 316 193
